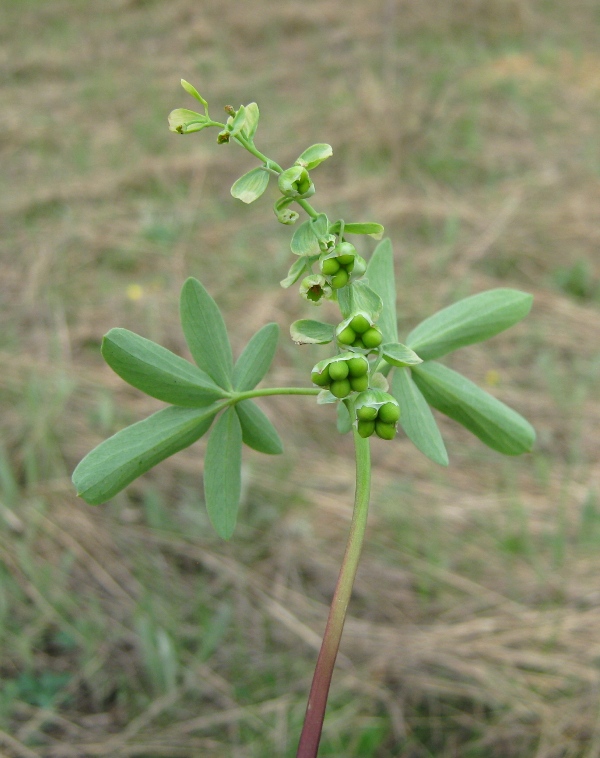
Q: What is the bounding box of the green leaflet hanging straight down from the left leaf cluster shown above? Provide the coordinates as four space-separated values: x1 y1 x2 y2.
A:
204 408 242 540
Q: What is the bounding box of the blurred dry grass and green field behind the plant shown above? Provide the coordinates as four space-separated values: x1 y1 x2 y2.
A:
0 0 600 758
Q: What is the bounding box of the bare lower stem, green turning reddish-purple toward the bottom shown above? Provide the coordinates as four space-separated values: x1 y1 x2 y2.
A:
296 430 371 758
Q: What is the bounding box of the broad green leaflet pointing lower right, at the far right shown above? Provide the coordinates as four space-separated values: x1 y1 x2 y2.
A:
412 362 535 455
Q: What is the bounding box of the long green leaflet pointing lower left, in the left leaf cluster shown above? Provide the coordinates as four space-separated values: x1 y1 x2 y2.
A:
73 403 223 505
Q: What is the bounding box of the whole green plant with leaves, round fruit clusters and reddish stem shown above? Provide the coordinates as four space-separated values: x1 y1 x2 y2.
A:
73 81 535 758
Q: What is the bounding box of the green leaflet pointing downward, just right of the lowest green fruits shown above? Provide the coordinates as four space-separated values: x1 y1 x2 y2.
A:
392 369 448 466
